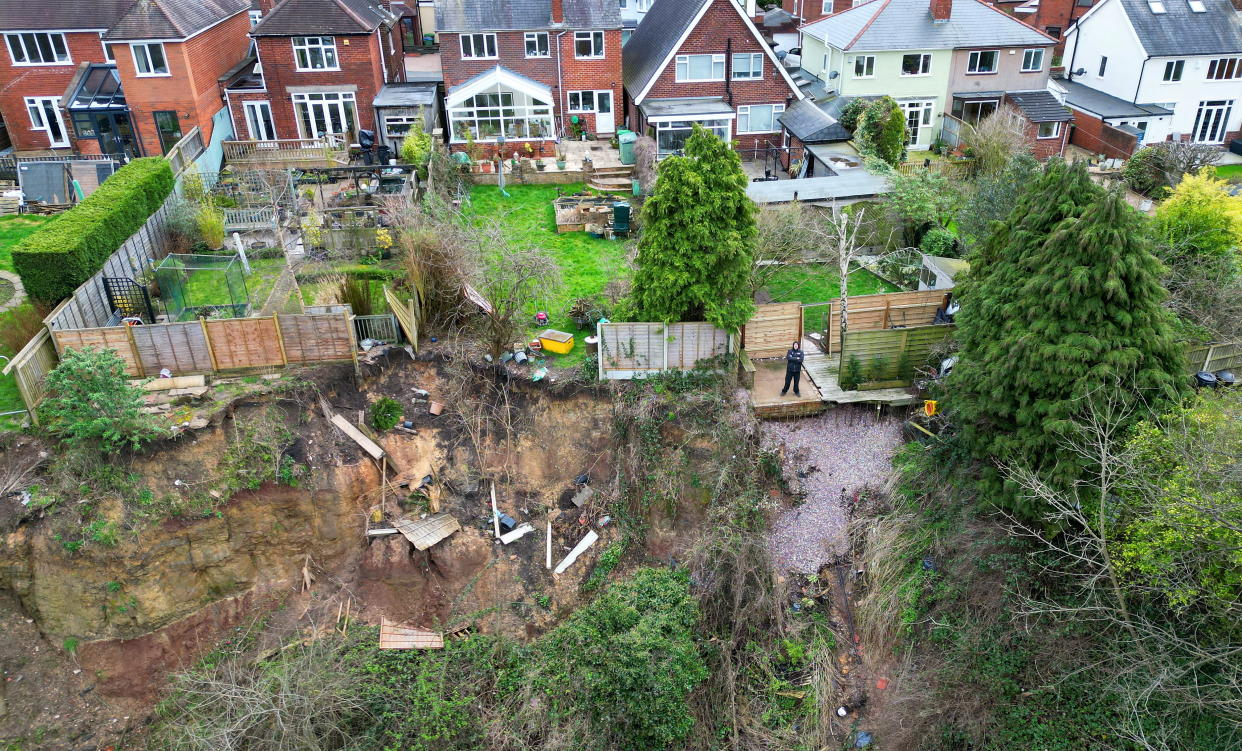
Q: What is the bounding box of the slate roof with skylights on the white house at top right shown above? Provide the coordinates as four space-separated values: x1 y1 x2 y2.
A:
1120 0 1242 57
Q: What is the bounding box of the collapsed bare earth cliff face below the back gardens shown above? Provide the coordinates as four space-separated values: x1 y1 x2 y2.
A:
0 362 617 699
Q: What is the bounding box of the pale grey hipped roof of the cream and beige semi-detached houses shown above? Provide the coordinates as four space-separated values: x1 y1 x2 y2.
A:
799 0 1053 52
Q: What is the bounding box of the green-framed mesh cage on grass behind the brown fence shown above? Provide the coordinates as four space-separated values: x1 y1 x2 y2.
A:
155 253 250 320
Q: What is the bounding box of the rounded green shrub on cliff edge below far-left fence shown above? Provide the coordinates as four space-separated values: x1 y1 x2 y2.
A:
40 346 164 452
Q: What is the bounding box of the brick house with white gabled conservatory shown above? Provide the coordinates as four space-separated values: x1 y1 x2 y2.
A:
436 0 622 156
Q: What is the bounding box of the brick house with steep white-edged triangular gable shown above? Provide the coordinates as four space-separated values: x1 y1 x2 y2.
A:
625 0 804 155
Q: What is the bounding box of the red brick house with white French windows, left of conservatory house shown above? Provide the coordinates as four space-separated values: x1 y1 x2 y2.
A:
222 0 405 142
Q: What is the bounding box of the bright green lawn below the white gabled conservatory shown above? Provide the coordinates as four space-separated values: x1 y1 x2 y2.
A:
462 184 628 367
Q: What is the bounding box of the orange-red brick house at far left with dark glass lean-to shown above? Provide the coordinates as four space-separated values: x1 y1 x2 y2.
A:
0 0 250 158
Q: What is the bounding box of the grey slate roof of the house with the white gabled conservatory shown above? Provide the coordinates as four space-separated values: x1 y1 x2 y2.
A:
436 0 622 31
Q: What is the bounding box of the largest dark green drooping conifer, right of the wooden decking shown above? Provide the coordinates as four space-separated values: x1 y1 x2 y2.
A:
949 164 1184 518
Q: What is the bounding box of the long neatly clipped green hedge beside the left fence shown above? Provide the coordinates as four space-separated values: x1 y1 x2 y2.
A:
12 156 174 304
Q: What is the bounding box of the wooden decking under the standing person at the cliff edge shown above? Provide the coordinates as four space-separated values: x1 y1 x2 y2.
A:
750 350 918 418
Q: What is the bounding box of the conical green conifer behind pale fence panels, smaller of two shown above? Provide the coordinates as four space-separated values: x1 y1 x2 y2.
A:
633 125 758 331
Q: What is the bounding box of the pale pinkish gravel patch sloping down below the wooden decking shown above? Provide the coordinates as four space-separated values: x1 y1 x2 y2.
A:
763 408 902 573
